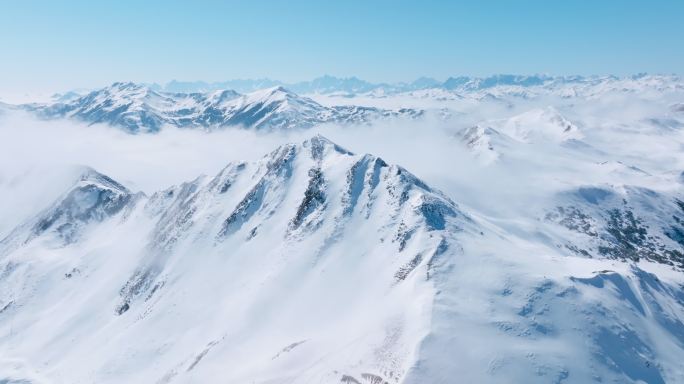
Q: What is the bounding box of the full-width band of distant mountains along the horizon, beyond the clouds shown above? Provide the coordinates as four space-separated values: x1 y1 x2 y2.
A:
10 74 684 133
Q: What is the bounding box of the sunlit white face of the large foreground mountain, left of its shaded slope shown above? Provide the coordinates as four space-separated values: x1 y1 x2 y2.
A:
0 137 468 382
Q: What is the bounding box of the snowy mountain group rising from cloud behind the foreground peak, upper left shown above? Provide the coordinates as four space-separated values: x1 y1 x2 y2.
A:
25 83 422 132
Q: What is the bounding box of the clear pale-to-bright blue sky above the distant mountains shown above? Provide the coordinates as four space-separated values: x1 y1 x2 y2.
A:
0 0 684 90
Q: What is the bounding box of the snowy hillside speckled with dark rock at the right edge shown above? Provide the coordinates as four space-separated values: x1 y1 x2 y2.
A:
546 186 684 268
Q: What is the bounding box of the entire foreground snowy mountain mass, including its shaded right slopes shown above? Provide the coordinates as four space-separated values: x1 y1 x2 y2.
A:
0 136 684 384
